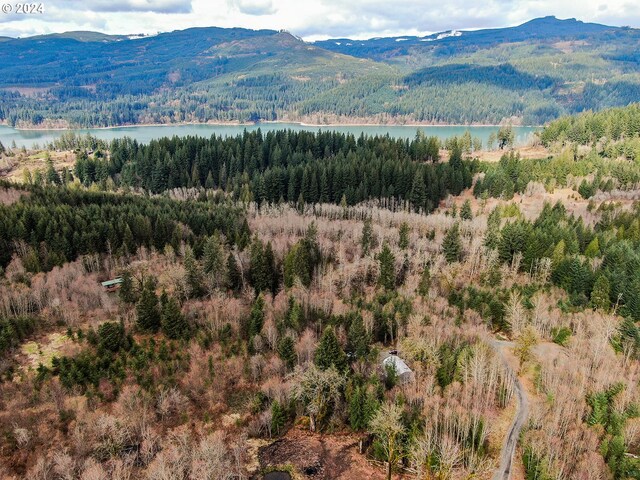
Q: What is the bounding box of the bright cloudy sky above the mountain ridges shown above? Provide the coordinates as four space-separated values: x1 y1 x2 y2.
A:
0 0 640 40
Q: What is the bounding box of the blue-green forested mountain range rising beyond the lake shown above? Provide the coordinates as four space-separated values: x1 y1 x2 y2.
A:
0 17 640 127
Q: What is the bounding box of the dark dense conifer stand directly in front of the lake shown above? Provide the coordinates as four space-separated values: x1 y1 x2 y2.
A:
90 130 473 212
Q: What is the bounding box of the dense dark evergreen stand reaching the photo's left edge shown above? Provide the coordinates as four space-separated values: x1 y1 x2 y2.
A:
0 182 243 272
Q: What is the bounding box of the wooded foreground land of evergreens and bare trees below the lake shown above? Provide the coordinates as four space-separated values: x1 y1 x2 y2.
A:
0 106 640 480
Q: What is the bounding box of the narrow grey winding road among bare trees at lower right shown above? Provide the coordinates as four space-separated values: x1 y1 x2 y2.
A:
491 340 529 480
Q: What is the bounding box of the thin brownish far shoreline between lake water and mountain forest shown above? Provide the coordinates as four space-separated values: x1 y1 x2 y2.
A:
0 120 544 132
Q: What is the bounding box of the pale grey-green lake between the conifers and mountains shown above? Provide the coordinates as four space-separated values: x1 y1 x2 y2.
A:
0 123 540 148
